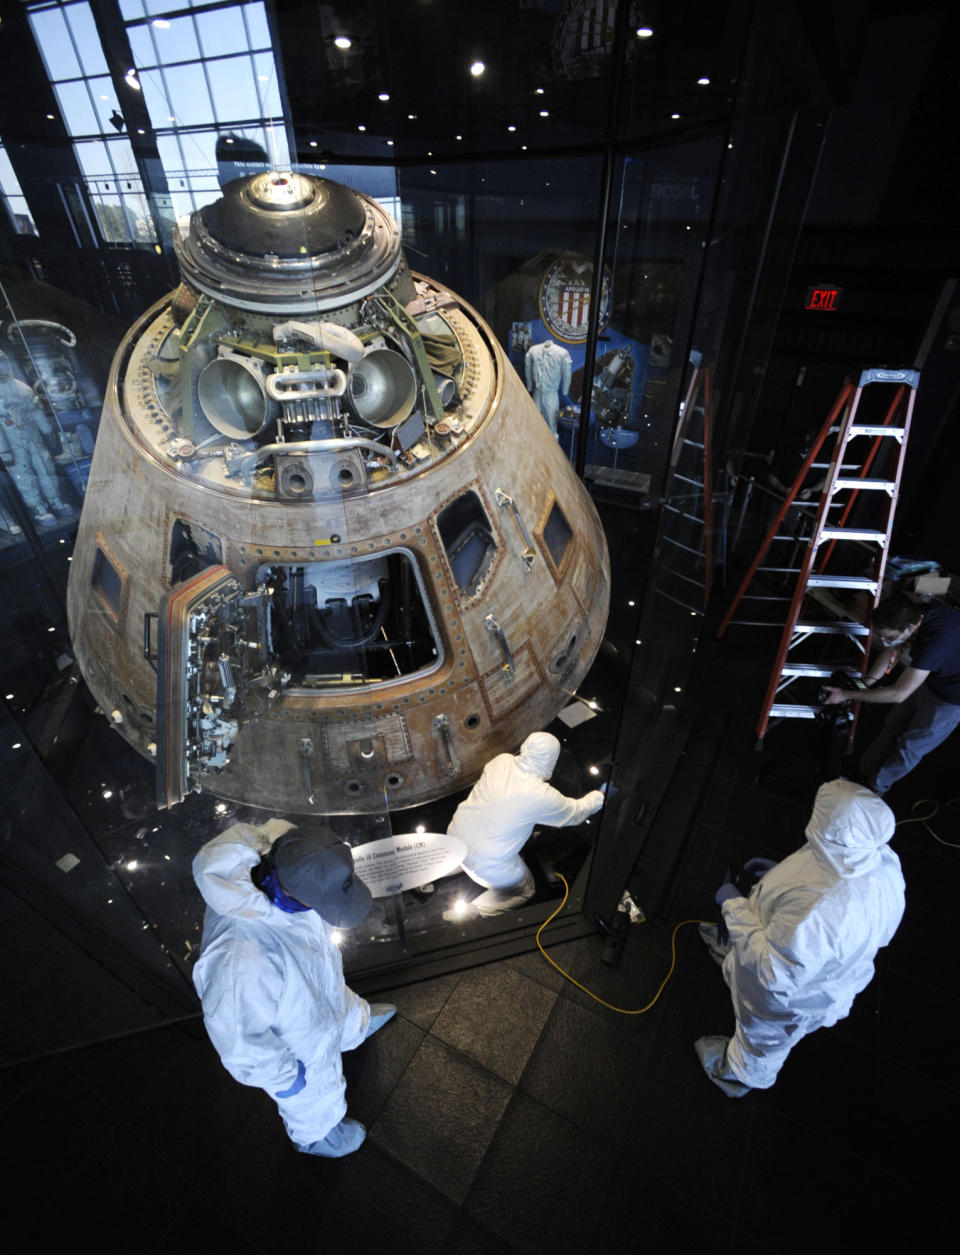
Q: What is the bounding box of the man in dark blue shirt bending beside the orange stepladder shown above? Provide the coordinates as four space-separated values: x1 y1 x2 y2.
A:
824 594 960 797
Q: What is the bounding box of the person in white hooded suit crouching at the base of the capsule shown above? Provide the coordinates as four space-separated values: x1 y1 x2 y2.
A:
443 732 604 920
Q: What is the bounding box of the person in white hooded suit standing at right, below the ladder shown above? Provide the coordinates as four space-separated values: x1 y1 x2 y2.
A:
695 779 904 1098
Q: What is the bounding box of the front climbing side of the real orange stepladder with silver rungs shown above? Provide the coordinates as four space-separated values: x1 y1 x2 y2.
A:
757 366 920 745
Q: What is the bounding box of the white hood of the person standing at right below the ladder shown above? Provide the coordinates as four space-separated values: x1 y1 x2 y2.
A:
806 779 896 876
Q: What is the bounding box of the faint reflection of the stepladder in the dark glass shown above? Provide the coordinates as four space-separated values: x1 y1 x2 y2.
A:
655 351 714 615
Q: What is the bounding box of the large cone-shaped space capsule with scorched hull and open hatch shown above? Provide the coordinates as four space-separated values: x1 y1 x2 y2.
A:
68 172 610 814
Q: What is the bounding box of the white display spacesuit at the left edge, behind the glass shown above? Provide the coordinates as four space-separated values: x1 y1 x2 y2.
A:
0 353 65 523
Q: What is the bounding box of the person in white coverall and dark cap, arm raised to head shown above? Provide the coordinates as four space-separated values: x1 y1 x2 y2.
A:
193 820 395 1158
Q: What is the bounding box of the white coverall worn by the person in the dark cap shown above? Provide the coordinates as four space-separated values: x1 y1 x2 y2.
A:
193 821 370 1148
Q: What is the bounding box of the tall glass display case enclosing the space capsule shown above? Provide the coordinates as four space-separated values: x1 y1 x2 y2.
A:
0 0 822 1053
